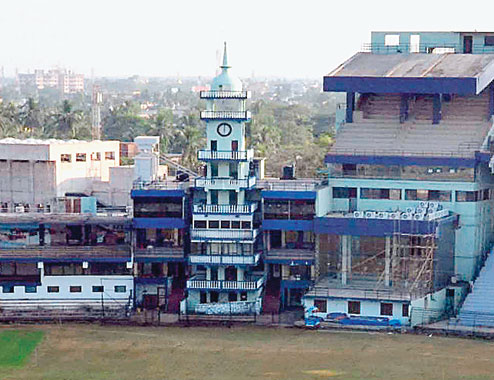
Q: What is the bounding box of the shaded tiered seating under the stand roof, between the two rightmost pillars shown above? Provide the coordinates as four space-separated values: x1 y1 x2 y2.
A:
441 93 489 122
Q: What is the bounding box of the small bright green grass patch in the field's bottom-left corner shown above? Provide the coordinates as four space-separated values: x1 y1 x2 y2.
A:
0 330 44 368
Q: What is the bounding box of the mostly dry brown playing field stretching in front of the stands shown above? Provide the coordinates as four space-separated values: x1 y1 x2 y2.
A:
0 325 494 380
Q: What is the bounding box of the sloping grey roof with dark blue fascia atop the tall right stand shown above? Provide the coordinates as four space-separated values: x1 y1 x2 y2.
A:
324 53 494 95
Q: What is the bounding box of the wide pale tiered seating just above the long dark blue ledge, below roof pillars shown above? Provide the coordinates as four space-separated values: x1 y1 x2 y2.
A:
330 121 490 157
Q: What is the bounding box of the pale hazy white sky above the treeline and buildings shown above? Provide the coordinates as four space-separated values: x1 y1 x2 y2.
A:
0 0 494 78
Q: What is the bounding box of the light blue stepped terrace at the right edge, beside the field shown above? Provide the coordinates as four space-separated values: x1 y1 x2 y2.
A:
458 252 494 327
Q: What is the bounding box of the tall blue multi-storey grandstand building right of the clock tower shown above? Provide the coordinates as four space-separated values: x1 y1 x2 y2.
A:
305 32 494 323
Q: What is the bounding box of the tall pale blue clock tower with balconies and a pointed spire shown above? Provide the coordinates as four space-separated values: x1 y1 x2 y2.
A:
187 43 264 314
